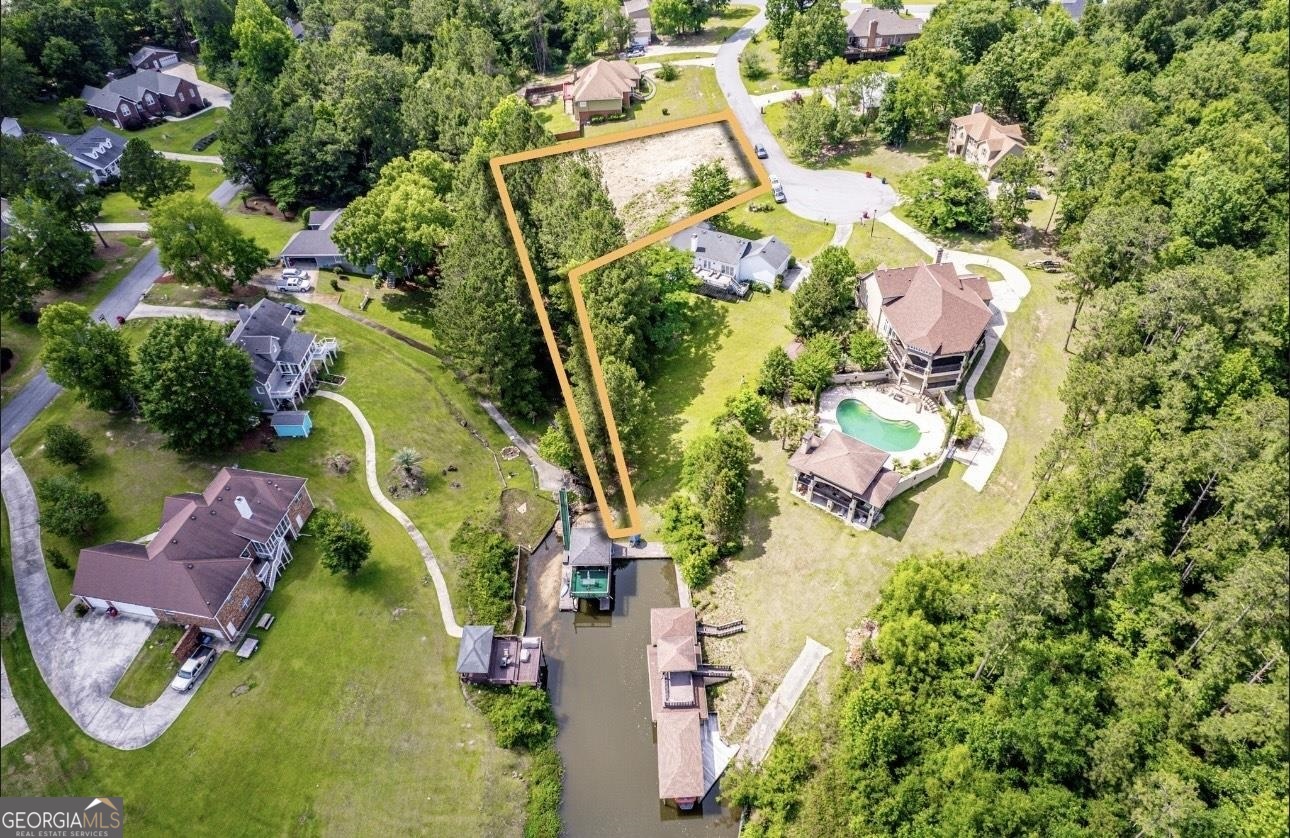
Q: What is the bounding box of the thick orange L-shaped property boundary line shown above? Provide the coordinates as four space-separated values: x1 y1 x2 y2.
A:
489 108 770 538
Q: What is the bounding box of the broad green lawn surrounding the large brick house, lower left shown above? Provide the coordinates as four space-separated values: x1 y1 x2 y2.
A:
0 307 546 835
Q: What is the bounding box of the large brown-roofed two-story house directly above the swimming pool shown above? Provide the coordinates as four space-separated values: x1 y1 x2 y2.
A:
855 263 993 392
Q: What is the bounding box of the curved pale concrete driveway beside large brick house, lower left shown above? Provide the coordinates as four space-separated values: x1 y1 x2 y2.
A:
0 449 201 750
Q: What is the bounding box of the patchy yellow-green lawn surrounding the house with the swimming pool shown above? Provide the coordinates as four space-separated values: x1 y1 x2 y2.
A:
635 224 1069 685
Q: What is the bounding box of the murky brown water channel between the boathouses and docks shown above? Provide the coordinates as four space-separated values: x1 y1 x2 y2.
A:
528 536 739 838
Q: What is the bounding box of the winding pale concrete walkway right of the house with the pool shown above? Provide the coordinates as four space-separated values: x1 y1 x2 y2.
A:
878 213 1031 491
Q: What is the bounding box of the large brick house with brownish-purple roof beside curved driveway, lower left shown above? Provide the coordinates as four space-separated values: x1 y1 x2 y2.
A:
72 468 313 641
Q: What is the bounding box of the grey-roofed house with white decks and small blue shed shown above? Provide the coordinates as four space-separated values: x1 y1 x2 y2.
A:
227 299 341 436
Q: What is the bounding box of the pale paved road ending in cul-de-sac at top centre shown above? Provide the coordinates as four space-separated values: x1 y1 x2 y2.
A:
717 0 897 224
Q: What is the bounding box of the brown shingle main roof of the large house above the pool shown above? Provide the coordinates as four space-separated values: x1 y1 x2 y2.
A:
873 263 992 355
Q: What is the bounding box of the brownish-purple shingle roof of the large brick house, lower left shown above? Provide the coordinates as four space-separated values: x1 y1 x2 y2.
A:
72 468 304 616
